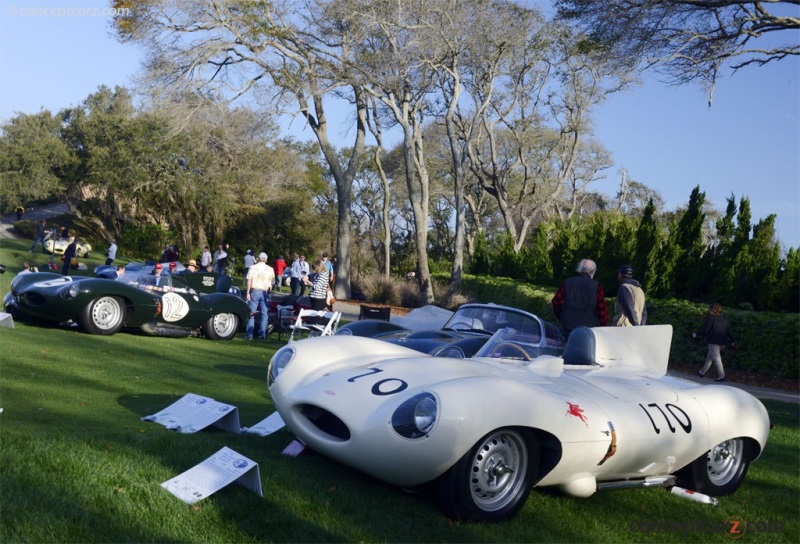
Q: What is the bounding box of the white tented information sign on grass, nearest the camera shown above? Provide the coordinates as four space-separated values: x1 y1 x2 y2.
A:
161 446 264 504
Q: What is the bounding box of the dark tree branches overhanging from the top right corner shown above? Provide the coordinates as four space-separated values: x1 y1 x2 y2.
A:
556 0 800 104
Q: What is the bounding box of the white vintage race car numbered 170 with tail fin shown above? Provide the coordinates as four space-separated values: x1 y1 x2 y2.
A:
268 325 770 521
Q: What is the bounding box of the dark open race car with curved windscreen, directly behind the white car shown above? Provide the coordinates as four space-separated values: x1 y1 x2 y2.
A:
336 303 564 358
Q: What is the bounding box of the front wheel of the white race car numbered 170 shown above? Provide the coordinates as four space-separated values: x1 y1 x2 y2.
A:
436 428 539 521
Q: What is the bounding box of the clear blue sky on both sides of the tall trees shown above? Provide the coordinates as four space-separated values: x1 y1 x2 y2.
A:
0 0 800 248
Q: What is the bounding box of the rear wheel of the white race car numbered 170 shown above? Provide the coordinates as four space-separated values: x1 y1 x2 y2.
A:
678 438 753 497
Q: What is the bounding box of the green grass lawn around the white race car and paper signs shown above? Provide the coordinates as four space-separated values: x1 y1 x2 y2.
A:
0 241 800 543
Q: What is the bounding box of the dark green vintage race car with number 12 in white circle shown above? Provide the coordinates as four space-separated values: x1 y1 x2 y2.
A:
4 272 250 340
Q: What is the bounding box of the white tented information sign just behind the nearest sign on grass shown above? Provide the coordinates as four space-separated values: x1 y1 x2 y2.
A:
142 393 241 434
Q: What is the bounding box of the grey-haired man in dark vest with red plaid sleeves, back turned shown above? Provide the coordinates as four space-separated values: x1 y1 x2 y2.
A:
552 259 608 337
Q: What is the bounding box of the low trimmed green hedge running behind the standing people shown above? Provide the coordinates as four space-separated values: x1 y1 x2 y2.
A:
454 275 800 379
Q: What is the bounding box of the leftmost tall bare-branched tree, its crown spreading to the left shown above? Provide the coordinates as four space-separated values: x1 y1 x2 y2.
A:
114 0 367 298
